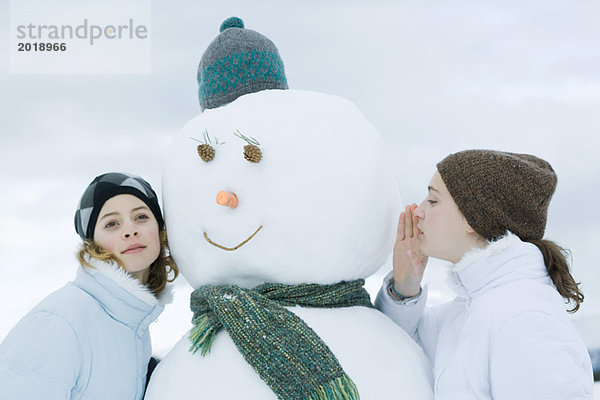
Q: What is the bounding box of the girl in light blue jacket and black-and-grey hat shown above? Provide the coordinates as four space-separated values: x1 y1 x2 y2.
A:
0 173 178 400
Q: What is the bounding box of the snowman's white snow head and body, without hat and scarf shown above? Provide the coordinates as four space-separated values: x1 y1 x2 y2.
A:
146 90 433 400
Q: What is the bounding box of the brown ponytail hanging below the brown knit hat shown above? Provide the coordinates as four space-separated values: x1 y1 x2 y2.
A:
530 239 583 313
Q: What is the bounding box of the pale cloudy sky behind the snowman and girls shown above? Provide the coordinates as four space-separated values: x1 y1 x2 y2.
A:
0 0 600 344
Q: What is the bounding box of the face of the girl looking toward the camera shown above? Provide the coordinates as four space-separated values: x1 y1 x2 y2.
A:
94 194 160 283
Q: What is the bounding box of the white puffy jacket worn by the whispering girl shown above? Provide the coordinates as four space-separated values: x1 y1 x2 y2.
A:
375 233 593 400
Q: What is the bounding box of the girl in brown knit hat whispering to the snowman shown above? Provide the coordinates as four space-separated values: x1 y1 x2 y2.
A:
375 150 593 400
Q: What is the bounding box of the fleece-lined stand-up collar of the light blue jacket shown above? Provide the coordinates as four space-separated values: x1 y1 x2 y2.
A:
73 257 172 335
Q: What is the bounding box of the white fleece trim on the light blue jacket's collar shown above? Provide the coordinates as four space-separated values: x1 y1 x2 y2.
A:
85 255 173 307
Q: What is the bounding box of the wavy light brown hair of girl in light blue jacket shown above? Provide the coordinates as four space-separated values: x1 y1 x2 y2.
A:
77 230 179 296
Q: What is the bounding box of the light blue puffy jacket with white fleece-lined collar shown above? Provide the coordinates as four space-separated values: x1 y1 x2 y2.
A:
0 260 164 400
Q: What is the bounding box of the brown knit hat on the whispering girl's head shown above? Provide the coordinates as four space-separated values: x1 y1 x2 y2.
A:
437 150 557 241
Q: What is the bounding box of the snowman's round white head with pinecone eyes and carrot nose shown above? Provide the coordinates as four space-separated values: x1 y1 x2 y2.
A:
162 90 400 288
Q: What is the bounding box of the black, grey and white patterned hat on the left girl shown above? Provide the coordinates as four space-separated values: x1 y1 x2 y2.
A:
75 172 164 240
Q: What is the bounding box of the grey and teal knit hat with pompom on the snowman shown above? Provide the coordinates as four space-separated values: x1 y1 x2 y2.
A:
198 17 288 111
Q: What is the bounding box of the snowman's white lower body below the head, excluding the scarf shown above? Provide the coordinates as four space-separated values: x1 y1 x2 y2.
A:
146 307 433 400
